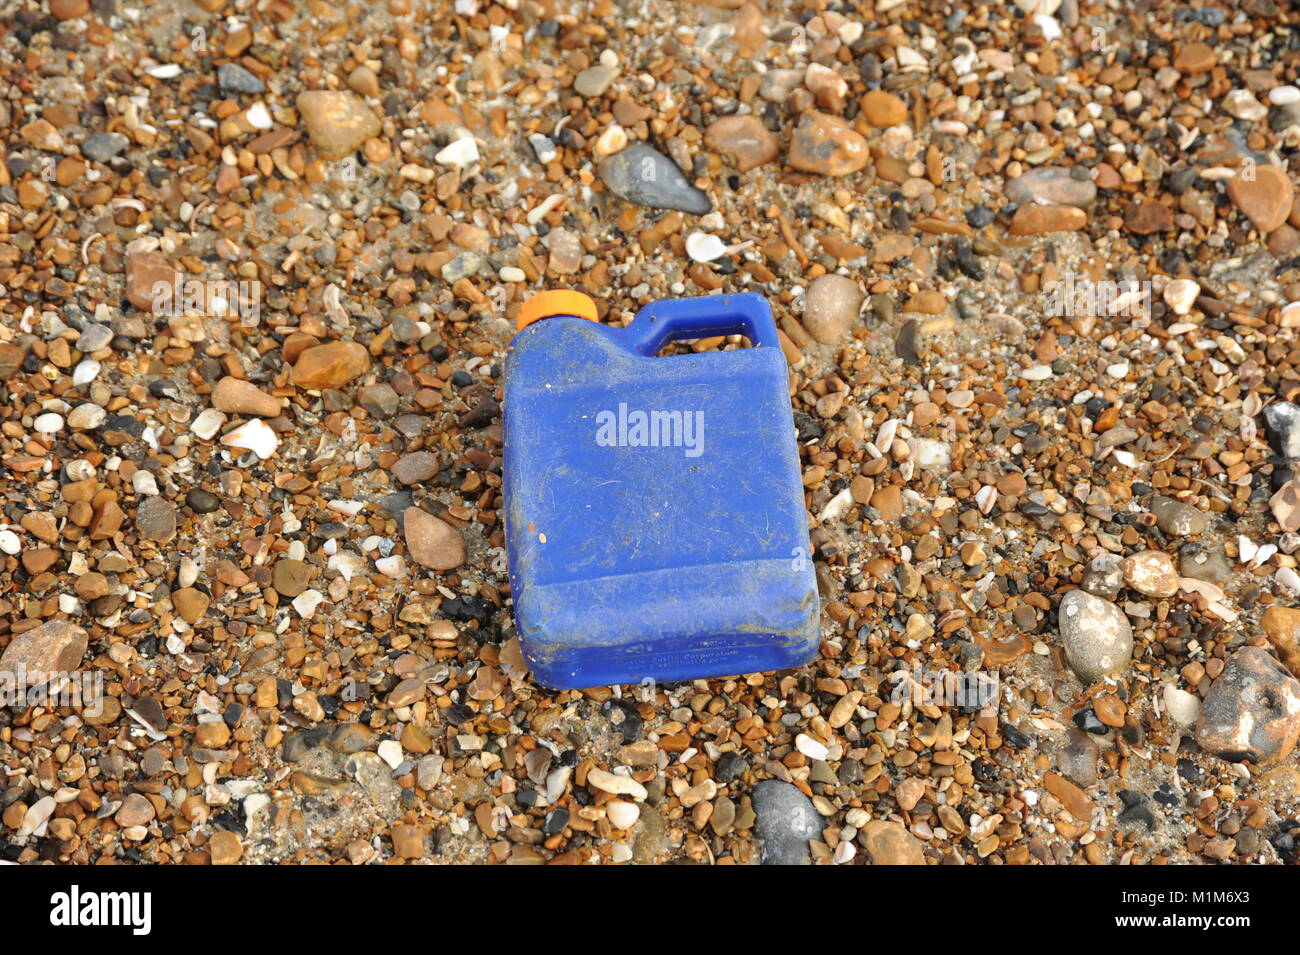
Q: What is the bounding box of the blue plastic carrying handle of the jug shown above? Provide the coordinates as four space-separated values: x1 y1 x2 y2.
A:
624 292 781 356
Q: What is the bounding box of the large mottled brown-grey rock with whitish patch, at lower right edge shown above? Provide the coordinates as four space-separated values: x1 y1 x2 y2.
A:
1196 647 1300 763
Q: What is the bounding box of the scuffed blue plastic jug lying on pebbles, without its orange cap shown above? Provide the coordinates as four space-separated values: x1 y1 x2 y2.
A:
503 292 820 689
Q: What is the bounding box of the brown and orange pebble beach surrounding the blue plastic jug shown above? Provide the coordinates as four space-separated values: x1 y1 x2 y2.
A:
0 0 1300 865
